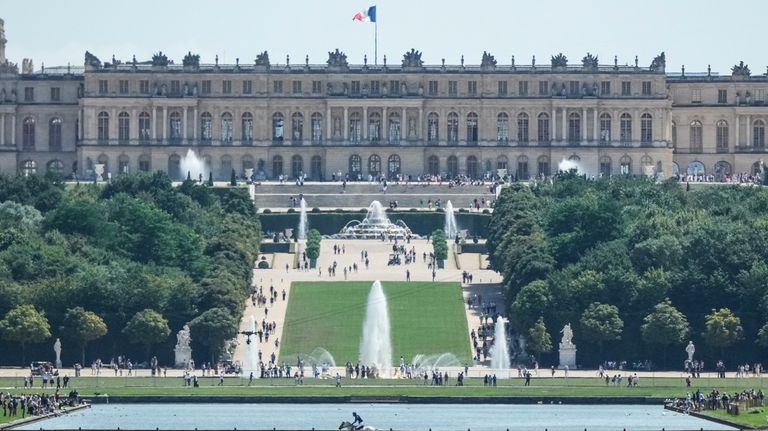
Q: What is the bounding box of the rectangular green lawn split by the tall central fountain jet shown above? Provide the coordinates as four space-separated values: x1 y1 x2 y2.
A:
279 281 472 365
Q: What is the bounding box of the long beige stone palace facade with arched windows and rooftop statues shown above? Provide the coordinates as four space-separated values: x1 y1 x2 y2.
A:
0 21 768 180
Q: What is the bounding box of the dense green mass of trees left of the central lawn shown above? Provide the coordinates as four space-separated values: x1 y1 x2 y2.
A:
0 173 261 367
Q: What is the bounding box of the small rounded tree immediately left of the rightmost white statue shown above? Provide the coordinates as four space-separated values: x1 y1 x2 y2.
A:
640 298 690 367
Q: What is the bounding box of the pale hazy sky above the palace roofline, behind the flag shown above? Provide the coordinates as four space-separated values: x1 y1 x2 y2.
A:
0 0 768 74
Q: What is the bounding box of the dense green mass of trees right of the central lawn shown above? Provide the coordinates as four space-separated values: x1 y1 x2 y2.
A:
488 174 768 370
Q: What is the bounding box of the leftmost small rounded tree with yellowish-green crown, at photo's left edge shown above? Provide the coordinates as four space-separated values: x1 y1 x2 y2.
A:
0 304 51 364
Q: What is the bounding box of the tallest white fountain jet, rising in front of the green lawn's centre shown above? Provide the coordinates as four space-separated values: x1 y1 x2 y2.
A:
360 280 392 378
